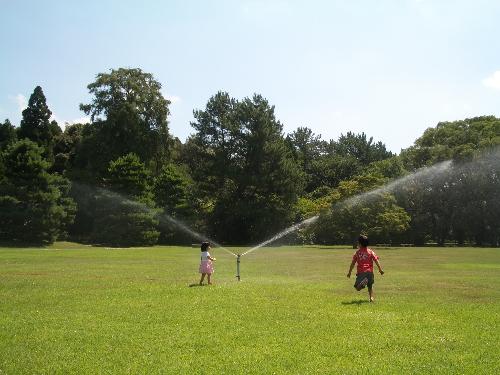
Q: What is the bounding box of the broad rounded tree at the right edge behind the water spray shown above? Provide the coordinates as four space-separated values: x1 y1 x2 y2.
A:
396 116 500 246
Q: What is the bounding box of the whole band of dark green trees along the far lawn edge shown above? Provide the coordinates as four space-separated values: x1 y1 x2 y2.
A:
0 68 500 246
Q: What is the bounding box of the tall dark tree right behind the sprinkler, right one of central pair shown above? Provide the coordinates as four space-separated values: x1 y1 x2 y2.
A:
229 95 304 241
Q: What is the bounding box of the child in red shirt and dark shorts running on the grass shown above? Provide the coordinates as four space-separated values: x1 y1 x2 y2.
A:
347 235 384 302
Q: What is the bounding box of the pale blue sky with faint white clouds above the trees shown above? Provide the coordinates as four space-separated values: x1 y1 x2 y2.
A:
0 0 500 152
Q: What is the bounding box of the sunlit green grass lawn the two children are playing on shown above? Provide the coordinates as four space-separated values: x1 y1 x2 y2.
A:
0 243 500 374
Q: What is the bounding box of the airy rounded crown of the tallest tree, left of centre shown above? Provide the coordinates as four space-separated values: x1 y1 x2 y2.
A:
80 68 172 172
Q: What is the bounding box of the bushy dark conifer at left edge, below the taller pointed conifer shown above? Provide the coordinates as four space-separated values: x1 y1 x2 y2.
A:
0 139 76 244
